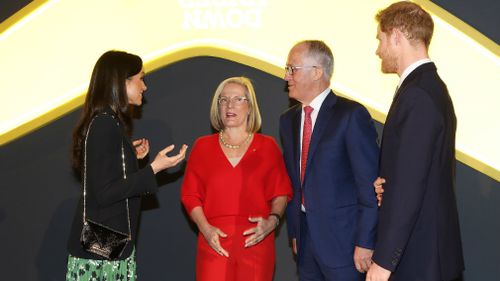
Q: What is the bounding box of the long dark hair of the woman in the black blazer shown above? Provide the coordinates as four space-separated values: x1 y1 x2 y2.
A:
72 51 142 172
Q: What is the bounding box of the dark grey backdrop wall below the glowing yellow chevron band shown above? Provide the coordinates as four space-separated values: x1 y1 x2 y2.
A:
0 57 500 281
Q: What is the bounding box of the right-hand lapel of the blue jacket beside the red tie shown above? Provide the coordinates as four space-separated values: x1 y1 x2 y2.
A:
299 91 337 182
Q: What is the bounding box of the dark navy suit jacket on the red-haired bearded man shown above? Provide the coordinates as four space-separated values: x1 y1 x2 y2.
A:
373 63 464 281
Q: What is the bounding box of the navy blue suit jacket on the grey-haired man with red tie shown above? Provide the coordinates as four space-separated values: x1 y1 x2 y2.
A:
280 92 379 267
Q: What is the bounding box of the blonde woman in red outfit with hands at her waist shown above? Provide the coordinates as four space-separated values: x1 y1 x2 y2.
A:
181 77 292 281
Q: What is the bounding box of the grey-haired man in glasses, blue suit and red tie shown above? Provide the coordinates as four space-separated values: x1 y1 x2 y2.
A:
280 40 379 281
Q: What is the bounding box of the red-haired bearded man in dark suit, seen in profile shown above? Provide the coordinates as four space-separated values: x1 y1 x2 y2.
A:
366 2 464 281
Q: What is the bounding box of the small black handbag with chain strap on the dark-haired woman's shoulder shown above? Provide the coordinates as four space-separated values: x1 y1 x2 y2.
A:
80 115 132 260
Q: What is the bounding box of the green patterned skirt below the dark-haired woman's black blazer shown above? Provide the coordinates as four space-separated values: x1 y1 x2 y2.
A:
66 249 137 281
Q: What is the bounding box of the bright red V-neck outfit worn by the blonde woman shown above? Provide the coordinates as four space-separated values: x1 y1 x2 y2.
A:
181 134 292 281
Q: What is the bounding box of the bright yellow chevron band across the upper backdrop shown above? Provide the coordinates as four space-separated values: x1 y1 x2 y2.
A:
0 0 500 181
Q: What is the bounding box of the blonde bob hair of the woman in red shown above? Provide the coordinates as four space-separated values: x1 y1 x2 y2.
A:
210 77 262 133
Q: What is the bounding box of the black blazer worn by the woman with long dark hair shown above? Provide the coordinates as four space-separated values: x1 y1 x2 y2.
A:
68 110 157 259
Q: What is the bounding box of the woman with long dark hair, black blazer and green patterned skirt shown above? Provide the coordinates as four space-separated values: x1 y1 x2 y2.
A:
66 51 187 280
